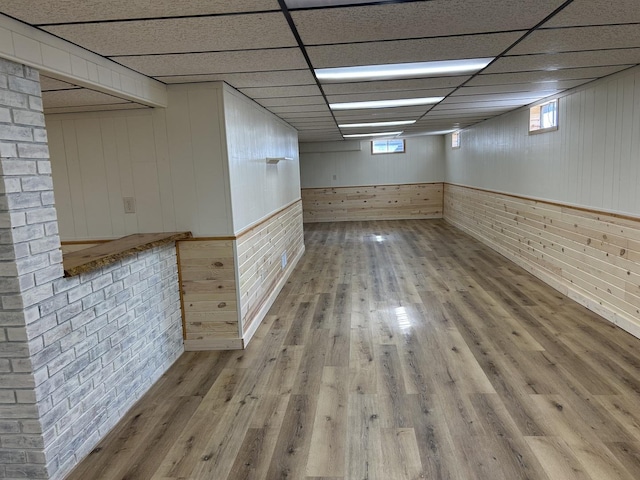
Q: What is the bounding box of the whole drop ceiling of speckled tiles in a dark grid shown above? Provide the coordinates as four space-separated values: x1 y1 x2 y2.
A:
0 0 640 141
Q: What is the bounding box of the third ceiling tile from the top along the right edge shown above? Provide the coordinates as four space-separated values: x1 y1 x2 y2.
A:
482 48 640 74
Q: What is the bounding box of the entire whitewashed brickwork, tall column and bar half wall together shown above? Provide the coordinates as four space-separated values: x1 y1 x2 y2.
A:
0 59 183 480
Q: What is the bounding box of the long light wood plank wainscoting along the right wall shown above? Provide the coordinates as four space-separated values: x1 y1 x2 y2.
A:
444 184 640 337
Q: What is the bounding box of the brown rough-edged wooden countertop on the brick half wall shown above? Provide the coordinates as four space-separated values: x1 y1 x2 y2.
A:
62 232 192 277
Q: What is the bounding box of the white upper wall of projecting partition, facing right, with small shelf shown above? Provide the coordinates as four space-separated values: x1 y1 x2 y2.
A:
224 86 300 233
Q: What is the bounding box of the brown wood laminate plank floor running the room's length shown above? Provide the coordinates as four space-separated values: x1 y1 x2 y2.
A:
69 220 640 480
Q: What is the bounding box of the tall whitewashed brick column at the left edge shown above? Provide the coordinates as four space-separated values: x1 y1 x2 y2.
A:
0 59 62 479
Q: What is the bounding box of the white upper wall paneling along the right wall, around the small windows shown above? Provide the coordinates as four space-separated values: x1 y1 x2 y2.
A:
444 64 640 215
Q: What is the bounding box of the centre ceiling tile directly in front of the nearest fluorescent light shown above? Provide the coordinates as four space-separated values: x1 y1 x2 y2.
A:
307 32 524 68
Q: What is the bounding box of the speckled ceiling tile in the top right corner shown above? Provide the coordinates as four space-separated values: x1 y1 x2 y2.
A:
543 0 640 28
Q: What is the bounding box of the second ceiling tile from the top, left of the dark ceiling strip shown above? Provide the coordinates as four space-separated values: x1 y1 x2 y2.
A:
44 12 297 56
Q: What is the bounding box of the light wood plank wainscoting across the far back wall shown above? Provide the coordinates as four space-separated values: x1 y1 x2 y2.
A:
302 182 443 223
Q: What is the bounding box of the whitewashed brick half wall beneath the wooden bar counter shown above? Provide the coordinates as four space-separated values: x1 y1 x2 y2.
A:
35 245 183 478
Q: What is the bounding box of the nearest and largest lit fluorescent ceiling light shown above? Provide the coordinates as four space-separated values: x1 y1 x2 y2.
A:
315 58 493 82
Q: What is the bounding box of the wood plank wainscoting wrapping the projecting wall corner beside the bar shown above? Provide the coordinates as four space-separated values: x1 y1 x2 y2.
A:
178 200 304 351
